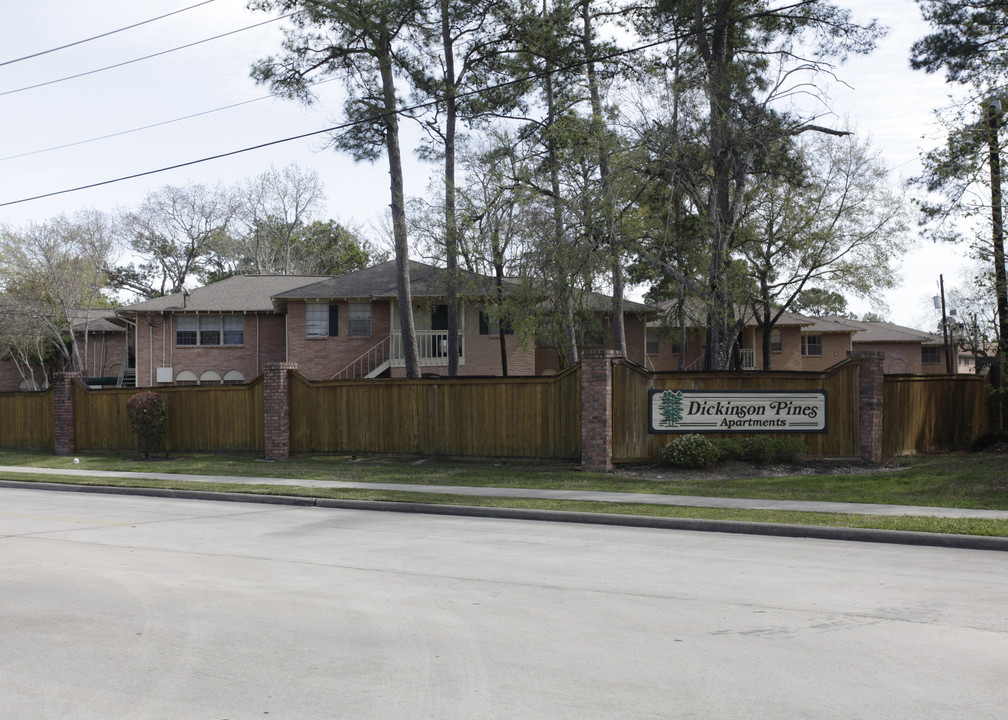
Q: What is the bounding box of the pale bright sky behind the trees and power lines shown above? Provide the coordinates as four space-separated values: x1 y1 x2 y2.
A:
0 0 968 329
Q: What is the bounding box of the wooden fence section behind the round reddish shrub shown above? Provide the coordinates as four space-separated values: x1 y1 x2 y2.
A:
74 377 265 452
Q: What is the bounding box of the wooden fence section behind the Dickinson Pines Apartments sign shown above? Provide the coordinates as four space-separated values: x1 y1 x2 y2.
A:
613 360 861 463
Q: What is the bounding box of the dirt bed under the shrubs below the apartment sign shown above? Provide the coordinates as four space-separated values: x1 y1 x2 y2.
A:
614 458 905 481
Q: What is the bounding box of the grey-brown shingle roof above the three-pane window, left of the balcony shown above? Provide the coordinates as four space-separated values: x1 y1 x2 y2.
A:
120 275 326 314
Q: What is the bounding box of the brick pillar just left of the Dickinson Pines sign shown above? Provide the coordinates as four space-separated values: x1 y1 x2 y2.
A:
581 348 623 472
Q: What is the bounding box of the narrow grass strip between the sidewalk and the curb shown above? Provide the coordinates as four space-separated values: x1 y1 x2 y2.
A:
0 471 1008 537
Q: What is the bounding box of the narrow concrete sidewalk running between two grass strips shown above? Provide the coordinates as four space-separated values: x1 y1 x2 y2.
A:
0 465 1008 520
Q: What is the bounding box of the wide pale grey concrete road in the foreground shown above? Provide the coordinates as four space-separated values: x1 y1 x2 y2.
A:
0 489 1008 720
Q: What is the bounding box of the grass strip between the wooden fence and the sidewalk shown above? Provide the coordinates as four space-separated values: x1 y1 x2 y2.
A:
0 450 1008 509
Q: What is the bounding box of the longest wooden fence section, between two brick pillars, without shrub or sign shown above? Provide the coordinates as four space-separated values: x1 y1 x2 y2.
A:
289 367 581 460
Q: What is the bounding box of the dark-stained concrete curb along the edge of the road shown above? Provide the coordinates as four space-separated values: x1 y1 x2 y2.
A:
0 480 1008 552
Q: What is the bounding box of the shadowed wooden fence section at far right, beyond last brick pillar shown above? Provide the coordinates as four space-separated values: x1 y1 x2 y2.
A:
882 375 991 457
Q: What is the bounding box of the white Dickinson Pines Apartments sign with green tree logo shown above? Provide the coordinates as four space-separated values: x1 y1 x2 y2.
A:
648 390 826 433
